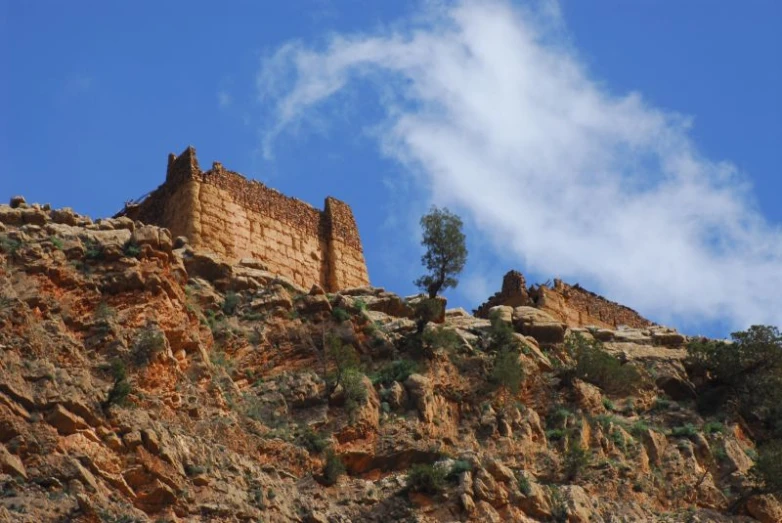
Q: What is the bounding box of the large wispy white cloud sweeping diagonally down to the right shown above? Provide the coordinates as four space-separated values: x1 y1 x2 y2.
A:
258 1 782 327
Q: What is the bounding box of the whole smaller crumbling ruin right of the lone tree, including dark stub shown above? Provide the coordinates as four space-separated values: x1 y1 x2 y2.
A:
475 271 653 329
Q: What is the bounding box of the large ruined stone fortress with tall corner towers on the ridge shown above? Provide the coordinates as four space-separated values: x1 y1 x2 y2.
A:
120 147 369 291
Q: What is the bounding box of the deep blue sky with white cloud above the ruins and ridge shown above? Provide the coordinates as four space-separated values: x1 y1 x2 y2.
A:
0 0 782 337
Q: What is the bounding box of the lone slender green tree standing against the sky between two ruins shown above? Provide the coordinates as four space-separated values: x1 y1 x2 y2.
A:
415 207 467 299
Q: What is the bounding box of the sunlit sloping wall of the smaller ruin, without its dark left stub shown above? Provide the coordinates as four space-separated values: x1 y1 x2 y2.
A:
530 280 654 329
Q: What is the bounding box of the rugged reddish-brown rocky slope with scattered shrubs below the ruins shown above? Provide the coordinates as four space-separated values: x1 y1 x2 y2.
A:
0 199 782 522
